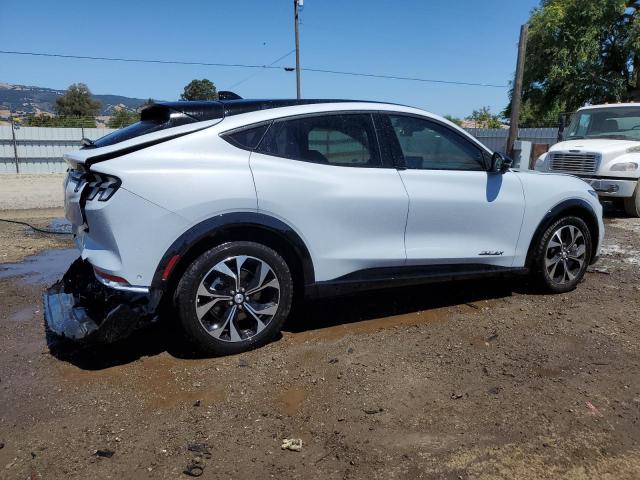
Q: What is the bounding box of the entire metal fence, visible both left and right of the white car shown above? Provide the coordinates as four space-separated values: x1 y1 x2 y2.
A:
0 126 558 174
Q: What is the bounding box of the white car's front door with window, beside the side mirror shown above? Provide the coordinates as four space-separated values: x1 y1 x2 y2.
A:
383 114 525 267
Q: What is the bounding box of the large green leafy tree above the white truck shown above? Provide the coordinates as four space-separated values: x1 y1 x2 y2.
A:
504 0 640 125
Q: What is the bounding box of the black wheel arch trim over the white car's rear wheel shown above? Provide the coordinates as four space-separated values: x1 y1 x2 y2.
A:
151 212 315 291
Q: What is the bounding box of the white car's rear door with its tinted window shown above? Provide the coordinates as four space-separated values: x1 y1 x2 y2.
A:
250 112 409 281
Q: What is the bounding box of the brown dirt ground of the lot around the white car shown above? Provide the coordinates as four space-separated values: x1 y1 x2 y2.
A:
0 211 640 480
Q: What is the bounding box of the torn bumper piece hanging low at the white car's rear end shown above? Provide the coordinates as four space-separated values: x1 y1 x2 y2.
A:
43 258 157 343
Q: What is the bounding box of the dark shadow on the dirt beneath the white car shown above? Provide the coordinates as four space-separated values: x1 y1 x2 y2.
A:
47 278 522 370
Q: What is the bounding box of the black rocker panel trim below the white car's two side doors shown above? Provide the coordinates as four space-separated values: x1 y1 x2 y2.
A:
307 264 529 298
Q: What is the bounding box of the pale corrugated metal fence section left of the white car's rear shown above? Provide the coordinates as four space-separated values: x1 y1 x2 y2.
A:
0 125 113 173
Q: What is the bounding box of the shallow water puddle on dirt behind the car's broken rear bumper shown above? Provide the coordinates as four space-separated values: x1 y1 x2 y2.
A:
0 248 80 285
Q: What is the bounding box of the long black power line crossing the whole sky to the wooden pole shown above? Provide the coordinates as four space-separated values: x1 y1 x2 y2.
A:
0 50 509 88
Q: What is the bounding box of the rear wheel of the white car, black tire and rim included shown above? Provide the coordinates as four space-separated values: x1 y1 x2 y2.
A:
175 242 293 355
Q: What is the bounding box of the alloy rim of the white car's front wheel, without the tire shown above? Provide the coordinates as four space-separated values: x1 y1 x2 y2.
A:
544 225 587 285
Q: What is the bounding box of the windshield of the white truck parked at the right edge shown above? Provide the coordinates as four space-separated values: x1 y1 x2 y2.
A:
564 105 640 141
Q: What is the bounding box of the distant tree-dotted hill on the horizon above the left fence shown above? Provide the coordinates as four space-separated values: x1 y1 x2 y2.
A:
0 83 147 115
